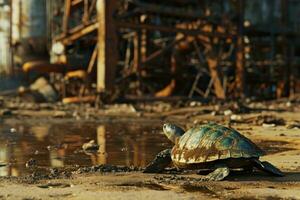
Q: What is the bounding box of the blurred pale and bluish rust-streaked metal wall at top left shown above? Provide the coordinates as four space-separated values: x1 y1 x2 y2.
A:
11 0 48 65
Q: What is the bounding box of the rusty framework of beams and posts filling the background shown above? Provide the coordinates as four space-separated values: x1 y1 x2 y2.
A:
29 0 300 99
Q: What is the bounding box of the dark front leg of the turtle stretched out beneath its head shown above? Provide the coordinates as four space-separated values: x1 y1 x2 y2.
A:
143 149 172 173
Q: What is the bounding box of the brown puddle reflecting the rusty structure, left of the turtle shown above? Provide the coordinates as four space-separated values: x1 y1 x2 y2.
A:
0 122 171 176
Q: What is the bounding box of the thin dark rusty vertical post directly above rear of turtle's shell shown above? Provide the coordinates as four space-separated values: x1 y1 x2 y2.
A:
235 0 245 97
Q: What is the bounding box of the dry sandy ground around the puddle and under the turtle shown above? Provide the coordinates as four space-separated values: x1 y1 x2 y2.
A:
0 98 300 199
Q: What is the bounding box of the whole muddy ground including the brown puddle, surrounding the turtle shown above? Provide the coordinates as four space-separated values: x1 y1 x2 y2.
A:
0 96 300 200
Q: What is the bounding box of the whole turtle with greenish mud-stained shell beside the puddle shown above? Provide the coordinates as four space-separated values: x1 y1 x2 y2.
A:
144 123 284 181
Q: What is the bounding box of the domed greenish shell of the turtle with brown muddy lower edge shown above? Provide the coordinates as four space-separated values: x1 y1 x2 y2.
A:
171 123 264 165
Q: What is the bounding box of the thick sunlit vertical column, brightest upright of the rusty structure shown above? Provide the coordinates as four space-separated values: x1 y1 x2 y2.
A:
97 0 118 92
